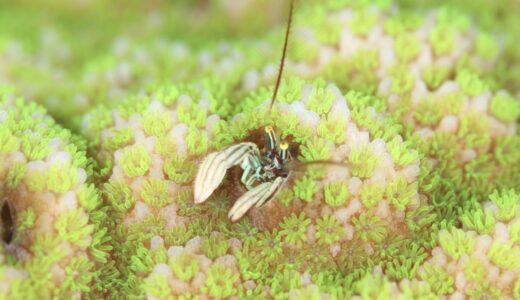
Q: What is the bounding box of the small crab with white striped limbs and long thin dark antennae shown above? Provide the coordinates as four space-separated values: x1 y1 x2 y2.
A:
194 0 341 222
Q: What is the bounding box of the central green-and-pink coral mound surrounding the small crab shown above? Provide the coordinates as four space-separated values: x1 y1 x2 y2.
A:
83 79 433 298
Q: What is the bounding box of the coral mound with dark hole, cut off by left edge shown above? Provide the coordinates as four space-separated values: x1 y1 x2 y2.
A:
0 89 110 299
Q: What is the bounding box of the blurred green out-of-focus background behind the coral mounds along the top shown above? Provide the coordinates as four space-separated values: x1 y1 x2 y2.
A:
0 0 520 128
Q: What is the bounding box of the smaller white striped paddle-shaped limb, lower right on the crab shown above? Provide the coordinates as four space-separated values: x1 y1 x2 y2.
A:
228 177 285 222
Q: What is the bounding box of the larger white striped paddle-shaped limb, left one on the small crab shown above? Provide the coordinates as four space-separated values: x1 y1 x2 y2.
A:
193 143 259 203
